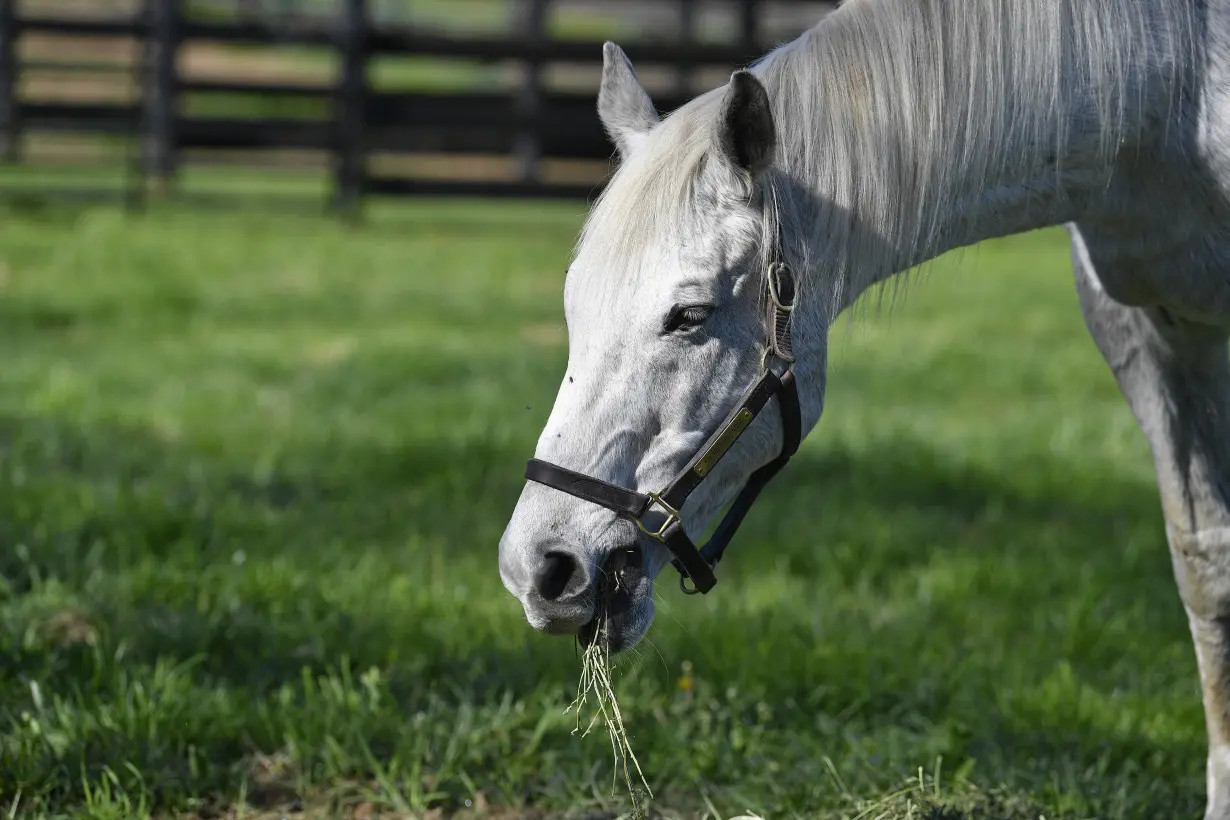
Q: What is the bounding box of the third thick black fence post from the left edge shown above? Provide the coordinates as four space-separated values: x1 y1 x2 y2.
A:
333 0 368 218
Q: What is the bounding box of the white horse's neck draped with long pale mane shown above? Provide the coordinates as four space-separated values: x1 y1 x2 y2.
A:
756 0 1196 312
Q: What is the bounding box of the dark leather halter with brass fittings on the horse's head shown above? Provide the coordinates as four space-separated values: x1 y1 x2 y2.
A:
525 262 802 595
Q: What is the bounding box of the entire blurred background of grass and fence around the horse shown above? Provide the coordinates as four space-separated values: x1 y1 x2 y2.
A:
0 0 1205 820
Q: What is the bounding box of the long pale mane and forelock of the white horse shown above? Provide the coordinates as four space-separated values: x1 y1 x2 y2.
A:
579 0 1199 317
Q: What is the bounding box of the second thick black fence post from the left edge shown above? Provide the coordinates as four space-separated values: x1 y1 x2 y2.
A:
145 0 181 195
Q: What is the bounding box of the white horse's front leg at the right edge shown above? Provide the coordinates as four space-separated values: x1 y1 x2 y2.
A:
1069 226 1230 820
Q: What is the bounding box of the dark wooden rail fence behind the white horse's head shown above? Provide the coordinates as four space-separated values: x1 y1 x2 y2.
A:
0 0 830 211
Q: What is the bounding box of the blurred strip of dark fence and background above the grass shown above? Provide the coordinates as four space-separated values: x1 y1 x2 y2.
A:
0 0 831 208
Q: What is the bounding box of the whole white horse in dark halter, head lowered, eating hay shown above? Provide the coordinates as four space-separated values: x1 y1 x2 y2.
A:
499 0 1230 820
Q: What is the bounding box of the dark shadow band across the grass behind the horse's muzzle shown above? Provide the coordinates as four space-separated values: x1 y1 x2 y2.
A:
0 403 1181 682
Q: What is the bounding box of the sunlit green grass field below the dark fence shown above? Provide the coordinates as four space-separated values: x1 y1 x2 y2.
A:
0 194 1204 820
